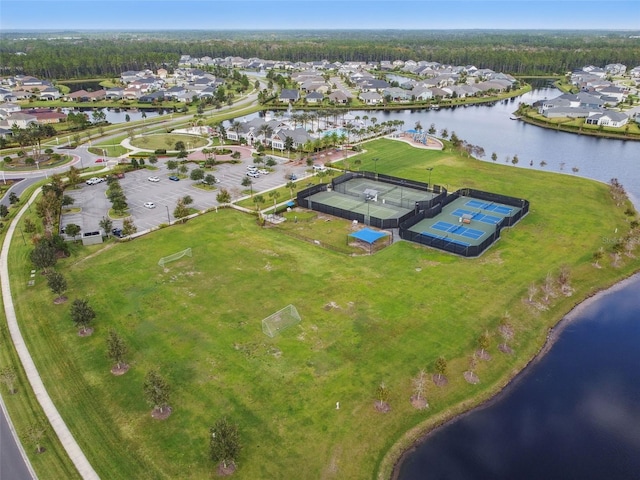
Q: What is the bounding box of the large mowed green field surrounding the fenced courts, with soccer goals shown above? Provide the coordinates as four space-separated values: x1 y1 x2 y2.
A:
9 140 640 479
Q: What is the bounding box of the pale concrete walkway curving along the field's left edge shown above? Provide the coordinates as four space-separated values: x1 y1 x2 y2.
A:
0 189 100 479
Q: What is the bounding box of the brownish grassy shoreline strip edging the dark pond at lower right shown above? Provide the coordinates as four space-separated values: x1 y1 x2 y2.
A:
388 270 640 480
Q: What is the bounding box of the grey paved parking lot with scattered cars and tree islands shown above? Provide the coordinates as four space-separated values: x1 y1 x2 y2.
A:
60 158 310 233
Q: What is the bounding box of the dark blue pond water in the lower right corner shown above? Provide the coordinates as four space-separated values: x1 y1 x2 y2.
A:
398 276 640 480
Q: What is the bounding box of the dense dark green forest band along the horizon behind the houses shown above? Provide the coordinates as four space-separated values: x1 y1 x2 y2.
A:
0 31 640 79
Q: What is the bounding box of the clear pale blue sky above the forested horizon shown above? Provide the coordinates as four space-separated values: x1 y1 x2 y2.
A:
0 0 640 31
